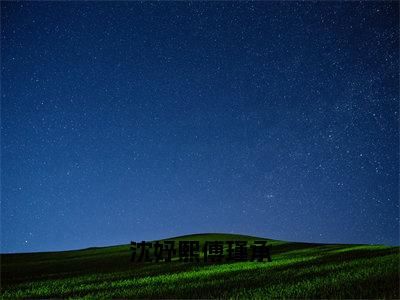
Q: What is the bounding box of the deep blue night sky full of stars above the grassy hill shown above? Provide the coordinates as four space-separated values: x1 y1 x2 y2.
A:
1 1 399 252
